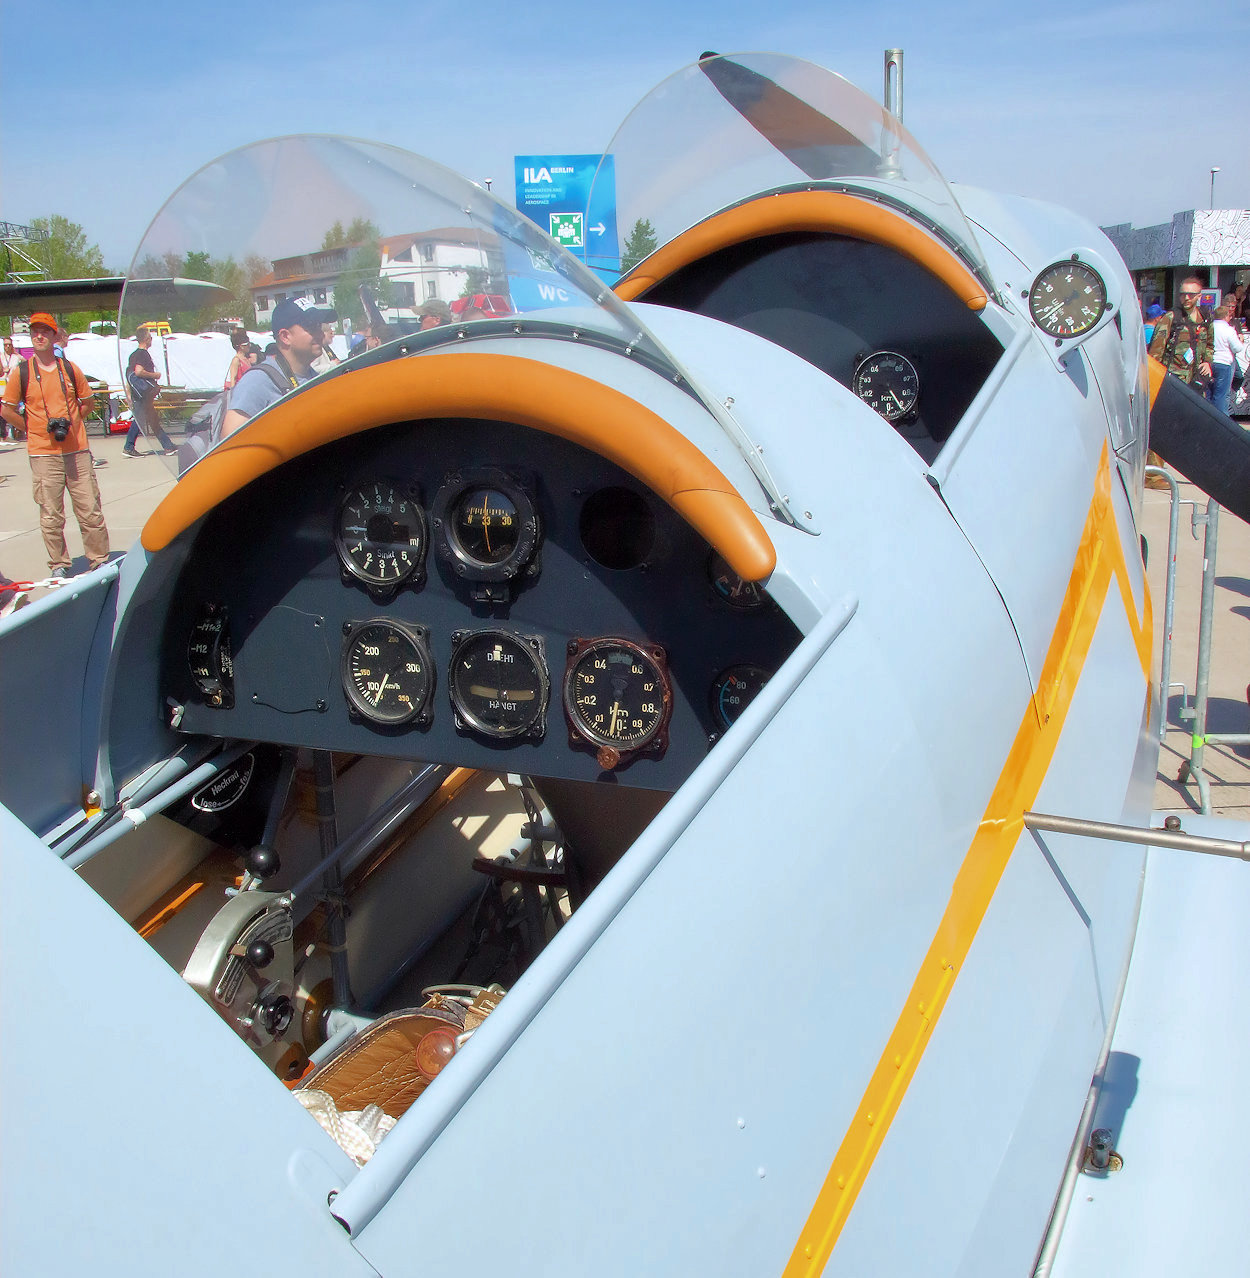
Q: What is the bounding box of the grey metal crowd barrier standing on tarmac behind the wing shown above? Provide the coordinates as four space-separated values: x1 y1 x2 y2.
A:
1146 466 1250 814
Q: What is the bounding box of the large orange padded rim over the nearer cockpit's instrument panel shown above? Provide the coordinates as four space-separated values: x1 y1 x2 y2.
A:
141 351 777 581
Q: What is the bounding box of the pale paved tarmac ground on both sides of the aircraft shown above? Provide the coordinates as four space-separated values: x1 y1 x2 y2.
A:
0 435 1250 820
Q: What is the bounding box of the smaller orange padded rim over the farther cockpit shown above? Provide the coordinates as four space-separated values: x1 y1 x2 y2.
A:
616 190 989 311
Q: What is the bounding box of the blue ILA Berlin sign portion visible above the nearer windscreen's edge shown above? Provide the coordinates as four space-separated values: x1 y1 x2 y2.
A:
514 155 621 282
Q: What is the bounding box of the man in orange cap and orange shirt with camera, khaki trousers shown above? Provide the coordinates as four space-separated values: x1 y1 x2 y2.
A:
0 311 109 578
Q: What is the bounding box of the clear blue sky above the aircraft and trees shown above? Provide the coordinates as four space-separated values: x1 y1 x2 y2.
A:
0 0 1250 270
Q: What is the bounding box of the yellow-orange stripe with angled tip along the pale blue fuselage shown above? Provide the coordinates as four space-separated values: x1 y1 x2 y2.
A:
785 445 1152 1278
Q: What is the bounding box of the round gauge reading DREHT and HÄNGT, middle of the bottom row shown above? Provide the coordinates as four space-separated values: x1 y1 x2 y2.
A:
447 630 550 737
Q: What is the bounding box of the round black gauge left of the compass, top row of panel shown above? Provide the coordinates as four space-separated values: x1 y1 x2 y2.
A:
335 479 426 589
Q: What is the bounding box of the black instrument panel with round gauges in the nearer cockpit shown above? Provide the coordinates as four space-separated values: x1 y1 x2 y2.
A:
161 420 800 790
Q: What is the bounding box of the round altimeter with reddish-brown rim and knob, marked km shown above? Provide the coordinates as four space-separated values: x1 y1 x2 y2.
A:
564 639 672 771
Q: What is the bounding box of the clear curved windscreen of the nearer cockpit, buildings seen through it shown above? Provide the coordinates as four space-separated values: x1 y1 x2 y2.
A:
119 135 662 469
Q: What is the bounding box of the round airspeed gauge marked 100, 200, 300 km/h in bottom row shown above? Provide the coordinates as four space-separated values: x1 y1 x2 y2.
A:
341 621 435 726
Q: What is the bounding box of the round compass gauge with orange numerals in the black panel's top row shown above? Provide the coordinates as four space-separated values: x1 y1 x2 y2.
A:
429 466 539 602
